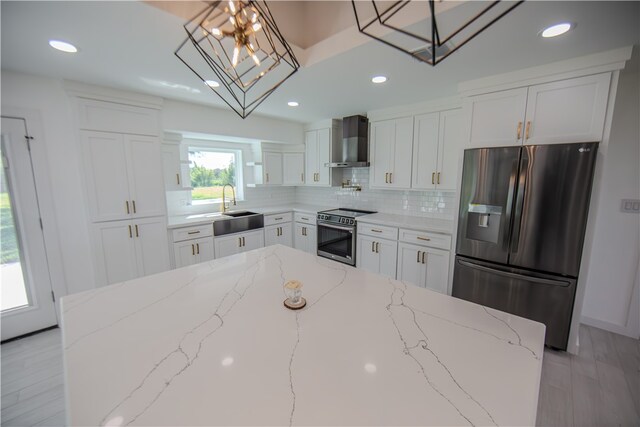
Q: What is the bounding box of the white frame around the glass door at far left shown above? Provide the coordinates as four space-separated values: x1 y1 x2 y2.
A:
2 106 73 332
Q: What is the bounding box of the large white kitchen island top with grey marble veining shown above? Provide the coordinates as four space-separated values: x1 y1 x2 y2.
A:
62 245 544 425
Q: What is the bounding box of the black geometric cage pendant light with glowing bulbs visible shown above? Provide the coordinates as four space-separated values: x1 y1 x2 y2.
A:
175 0 300 119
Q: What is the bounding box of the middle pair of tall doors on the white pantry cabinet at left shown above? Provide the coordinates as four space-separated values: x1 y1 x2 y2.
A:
82 131 165 222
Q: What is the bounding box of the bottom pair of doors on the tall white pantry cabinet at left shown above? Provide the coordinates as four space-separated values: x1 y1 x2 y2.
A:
93 217 169 286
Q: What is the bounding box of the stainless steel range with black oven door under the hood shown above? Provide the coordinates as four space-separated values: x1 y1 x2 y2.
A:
317 209 375 265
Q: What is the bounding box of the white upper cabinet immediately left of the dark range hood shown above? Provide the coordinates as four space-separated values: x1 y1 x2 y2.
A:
304 124 341 187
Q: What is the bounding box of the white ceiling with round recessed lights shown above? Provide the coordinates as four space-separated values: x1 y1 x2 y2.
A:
1 1 640 122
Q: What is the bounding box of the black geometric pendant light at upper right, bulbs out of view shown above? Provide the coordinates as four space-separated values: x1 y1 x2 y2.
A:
351 0 524 66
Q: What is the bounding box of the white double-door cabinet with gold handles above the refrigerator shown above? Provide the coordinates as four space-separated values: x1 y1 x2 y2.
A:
467 73 611 147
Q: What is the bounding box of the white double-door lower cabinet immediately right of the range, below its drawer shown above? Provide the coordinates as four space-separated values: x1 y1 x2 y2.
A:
356 235 398 279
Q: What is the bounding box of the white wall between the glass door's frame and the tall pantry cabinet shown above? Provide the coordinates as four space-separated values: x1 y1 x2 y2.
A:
2 70 95 293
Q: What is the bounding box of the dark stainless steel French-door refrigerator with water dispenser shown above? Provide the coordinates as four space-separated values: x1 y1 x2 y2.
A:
453 142 598 350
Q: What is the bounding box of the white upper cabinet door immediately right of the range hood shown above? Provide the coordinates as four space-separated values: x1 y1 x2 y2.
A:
369 120 395 188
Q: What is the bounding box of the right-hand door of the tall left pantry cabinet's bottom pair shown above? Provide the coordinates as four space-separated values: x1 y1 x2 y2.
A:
132 217 170 277
